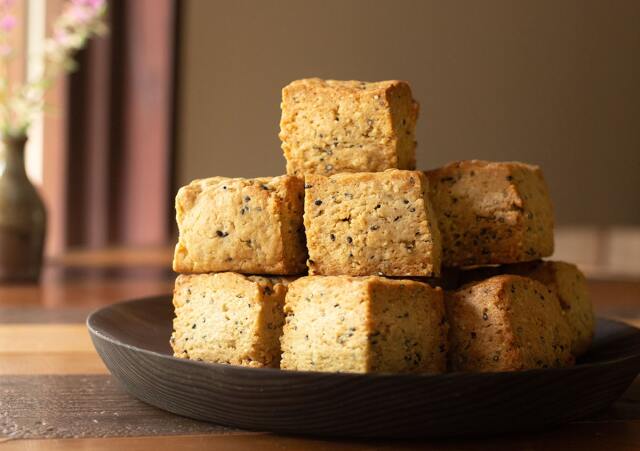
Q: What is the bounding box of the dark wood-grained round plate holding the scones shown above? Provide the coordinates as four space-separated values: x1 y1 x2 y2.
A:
87 296 640 438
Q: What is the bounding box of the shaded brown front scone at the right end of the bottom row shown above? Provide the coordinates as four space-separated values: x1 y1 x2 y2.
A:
445 275 574 372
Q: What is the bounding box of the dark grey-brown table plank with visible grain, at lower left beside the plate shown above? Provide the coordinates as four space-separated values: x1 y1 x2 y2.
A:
0 375 228 438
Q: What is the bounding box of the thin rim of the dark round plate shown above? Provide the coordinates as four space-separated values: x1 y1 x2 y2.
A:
85 293 640 379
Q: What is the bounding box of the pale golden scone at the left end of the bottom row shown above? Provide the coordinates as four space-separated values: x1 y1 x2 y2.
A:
171 272 292 368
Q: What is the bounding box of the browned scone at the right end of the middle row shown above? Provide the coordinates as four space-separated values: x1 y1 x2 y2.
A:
426 160 554 267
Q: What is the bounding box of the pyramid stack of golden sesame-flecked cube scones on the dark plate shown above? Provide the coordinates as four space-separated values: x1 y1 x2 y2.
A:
171 79 594 373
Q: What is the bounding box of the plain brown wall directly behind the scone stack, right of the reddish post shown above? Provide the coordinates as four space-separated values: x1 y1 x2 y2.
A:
177 0 640 224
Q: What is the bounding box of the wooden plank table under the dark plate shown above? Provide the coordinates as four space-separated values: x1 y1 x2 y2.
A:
0 249 640 451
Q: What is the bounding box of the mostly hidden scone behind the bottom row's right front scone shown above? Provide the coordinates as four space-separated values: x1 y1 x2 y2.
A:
461 260 595 357
